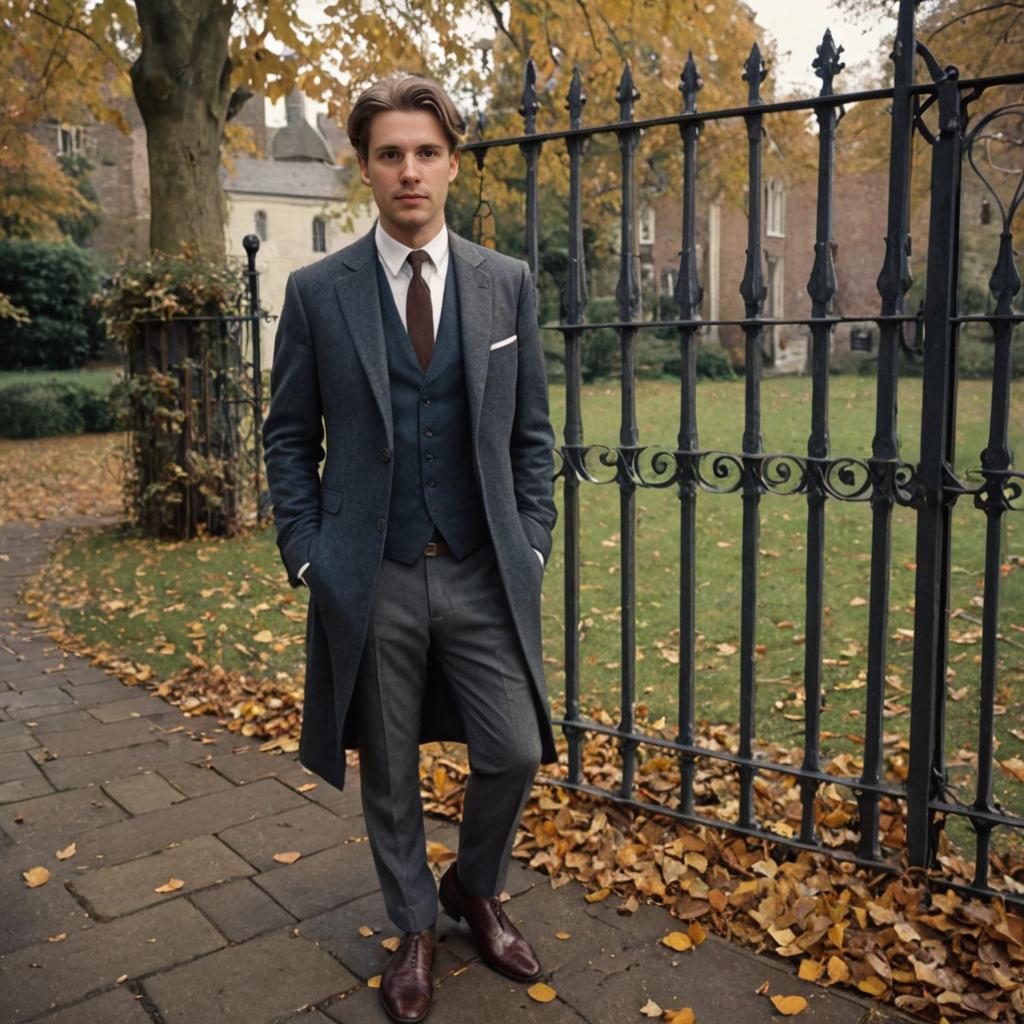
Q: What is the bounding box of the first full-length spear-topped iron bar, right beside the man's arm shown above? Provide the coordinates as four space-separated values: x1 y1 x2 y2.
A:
562 65 587 782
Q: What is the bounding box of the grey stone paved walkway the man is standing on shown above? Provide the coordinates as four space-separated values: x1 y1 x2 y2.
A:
0 522 904 1024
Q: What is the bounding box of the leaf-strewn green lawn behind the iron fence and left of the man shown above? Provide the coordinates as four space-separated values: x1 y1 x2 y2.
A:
41 376 1024 827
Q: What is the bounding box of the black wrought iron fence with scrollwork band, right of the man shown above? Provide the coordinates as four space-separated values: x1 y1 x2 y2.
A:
463 0 1024 898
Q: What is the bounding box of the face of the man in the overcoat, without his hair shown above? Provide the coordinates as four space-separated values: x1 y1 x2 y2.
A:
359 111 460 249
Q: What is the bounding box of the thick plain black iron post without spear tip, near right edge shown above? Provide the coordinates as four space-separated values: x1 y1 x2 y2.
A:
907 61 963 867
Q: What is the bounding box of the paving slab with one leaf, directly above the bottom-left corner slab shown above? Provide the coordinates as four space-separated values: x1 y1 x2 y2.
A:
69 836 253 921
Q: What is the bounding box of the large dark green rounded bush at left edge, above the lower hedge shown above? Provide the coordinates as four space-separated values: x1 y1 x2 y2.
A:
0 239 103 370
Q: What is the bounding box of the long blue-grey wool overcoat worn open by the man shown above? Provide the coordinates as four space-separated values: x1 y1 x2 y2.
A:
263 230 557 788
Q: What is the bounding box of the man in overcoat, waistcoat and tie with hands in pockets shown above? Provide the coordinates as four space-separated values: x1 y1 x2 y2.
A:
263 76 557 1021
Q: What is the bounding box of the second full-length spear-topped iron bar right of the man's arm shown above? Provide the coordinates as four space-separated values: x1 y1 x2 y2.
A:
615 61 640 798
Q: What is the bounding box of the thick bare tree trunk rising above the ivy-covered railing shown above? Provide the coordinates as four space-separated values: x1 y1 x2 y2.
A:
131 0 234 260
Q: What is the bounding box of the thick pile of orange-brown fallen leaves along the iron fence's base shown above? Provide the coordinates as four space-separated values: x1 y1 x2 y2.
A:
423 714 1024 1024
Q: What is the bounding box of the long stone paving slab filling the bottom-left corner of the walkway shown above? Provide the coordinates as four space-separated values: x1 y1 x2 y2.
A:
0 899 225 1024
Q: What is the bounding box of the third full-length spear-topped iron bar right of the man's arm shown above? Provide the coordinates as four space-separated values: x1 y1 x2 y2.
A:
676 51 703 814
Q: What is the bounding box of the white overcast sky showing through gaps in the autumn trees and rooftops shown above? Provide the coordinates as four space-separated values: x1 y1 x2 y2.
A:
266 0 895 126
